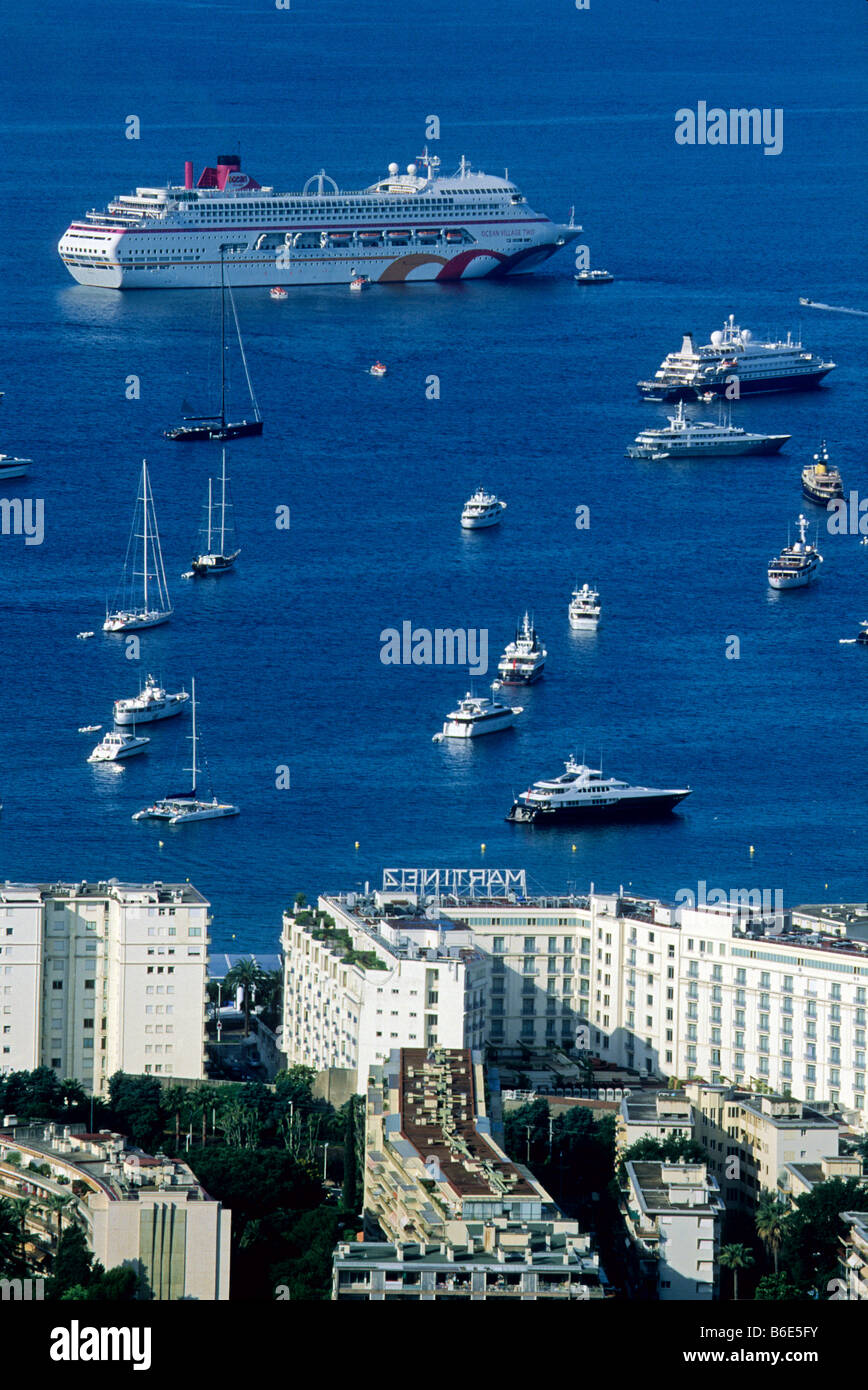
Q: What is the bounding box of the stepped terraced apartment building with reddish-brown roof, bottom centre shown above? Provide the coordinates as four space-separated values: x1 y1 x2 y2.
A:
346 1047 604 1300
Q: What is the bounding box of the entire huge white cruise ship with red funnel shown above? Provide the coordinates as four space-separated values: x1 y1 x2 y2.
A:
57 150 581 289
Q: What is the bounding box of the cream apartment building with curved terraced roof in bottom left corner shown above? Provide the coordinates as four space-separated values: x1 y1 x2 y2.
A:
0 1123 231 1300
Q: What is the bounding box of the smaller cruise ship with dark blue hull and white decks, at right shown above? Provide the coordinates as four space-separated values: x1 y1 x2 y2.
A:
637 314 835 400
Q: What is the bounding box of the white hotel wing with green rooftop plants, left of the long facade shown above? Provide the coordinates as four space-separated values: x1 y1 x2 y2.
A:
281 894 487 1093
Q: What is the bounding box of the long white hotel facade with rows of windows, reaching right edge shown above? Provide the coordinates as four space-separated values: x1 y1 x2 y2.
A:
434 892 868 1127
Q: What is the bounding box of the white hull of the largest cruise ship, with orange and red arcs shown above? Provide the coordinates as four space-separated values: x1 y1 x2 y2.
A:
57 218 580 289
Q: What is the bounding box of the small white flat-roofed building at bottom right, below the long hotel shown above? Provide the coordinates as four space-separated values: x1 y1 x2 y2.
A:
622 1162 723 1301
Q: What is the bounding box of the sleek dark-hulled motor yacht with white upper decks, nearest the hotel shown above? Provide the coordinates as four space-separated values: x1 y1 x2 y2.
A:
506 758 690 824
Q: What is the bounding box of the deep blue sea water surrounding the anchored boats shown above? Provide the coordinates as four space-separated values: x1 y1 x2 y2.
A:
0 0 868 949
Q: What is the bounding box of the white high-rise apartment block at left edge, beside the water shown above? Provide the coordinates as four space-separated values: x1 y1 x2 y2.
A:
0 880 210 1094
